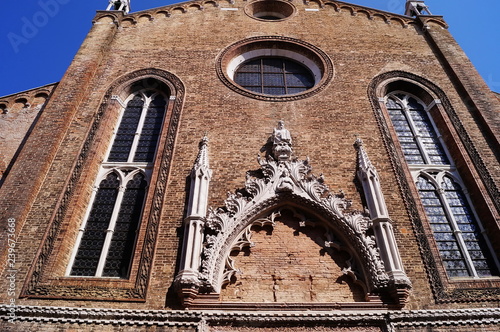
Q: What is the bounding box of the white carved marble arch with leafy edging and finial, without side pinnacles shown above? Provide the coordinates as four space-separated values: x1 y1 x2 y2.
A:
201 122 389 293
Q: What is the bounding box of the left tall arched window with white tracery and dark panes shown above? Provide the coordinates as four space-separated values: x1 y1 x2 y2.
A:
67 90 168 278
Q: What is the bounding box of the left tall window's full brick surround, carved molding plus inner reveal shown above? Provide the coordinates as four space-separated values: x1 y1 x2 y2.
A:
20 68 185 302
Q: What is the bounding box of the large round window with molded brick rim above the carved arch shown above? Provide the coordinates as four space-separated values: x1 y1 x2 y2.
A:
217 37 333 101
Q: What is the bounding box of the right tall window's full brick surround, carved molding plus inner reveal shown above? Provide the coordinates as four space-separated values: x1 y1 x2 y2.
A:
367 71 500 303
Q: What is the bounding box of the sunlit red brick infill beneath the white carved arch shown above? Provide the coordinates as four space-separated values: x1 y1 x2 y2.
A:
221 210 365 303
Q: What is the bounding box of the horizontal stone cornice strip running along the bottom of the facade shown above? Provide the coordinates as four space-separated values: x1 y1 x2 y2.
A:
0 304 500 332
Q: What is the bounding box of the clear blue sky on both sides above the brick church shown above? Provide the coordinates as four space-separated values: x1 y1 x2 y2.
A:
0 0 500 96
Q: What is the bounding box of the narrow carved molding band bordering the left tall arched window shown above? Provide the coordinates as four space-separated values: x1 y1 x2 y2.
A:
20 68 185 301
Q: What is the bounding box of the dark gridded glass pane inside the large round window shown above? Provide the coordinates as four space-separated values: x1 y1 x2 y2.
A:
234 57 314 96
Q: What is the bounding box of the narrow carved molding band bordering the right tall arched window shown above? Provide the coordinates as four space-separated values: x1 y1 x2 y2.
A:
368 71 500 303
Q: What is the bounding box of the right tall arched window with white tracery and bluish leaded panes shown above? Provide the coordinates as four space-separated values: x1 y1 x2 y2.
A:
385 91 499 278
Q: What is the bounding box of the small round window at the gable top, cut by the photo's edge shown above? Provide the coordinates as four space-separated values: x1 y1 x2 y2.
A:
245 0 296 21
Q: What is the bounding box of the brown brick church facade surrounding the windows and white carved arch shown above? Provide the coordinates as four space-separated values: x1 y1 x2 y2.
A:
0 0 500 331
